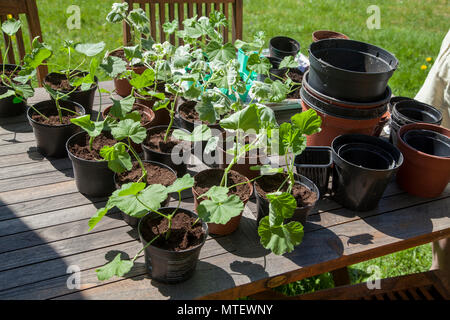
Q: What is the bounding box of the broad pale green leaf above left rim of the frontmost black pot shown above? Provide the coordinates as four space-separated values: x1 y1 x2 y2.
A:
108 182 168 218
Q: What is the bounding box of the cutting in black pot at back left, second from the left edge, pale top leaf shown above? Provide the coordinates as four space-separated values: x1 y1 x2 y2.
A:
44 40 105 113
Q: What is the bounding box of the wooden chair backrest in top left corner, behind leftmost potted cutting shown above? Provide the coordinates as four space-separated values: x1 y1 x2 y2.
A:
0 0 48 86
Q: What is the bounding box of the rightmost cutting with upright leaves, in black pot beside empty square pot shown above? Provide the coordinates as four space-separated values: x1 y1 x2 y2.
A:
254 110 322 224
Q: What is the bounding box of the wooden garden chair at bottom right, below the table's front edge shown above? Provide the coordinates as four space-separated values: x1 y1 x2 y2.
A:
250 270 450 300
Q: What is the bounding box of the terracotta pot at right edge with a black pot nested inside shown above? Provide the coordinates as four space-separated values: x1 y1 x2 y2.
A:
397 123 450 198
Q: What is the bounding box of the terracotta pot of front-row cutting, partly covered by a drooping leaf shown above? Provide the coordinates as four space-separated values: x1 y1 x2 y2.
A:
192 169 253 235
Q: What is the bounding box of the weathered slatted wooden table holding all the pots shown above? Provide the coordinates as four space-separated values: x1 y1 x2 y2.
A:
0 82 450 299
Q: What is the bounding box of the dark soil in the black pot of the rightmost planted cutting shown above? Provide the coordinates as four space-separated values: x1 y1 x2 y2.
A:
255 173 317 208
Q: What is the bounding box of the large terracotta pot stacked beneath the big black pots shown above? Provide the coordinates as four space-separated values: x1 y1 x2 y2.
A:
301 88 387 146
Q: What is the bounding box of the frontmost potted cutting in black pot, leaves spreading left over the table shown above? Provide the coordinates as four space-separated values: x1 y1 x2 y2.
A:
89 174 208 283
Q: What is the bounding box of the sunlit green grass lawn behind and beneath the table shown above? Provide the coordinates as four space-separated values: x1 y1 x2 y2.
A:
28 0 450 294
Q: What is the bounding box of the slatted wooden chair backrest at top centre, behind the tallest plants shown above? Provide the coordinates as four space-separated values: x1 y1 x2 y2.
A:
123 0 243 45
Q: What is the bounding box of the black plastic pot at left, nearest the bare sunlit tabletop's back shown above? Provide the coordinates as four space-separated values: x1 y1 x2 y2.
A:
27 100 85 158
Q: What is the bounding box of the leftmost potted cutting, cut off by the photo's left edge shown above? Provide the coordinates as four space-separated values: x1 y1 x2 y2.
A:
0 18 52 117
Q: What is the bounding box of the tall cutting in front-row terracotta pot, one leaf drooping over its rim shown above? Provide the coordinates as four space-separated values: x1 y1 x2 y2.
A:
192 104 277 234
